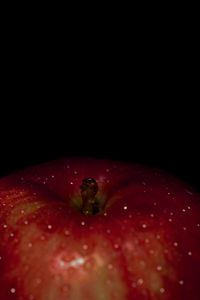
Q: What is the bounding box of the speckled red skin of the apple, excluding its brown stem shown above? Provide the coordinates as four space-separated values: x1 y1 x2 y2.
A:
0 158 200 300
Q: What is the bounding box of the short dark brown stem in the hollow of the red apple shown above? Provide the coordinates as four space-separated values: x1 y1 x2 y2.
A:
80 178 100 215
